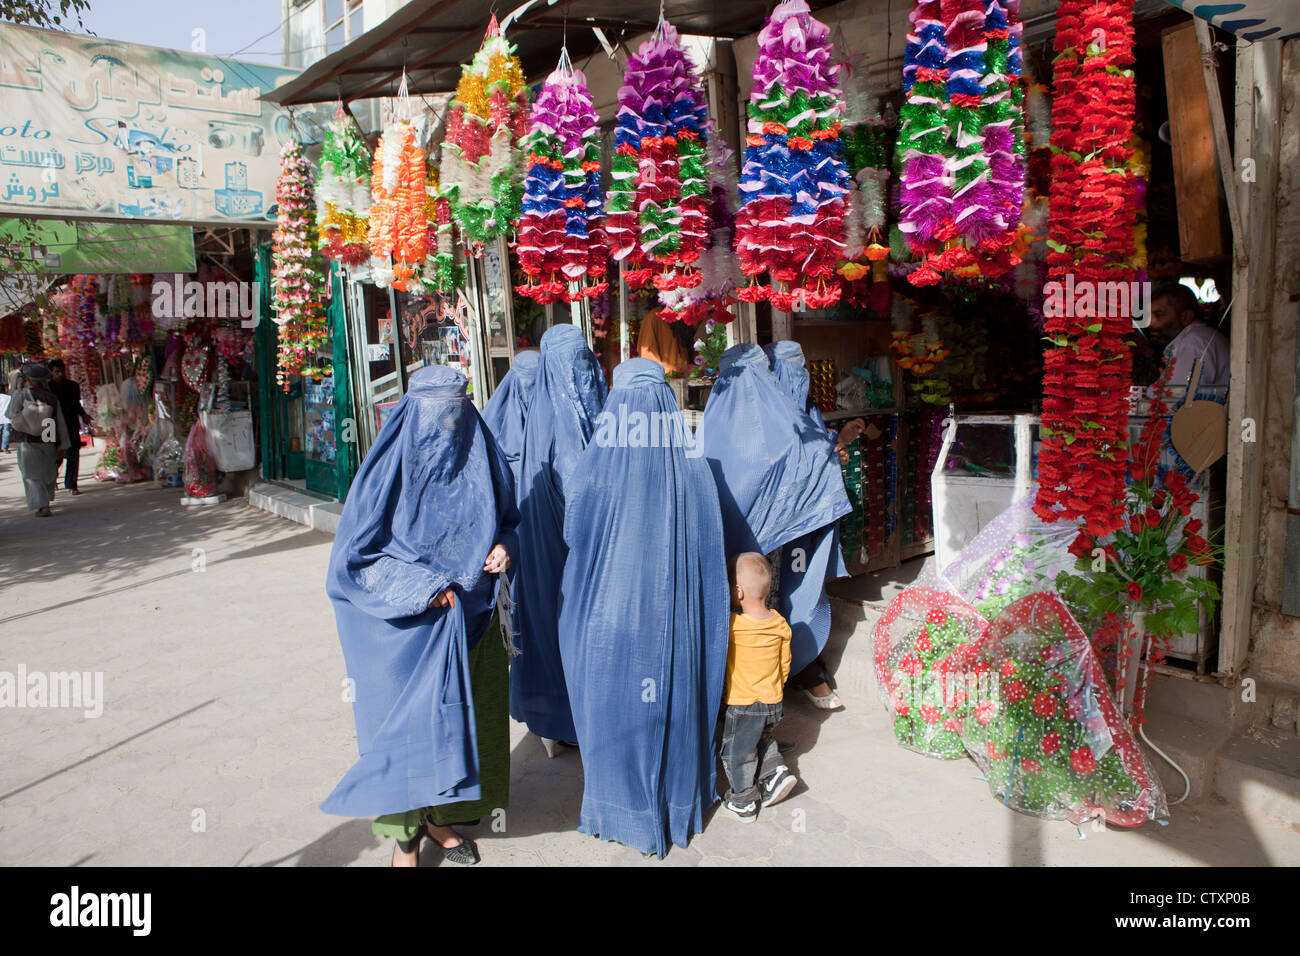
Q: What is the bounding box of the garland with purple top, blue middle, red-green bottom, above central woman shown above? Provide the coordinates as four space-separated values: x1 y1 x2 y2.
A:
606 18 710 310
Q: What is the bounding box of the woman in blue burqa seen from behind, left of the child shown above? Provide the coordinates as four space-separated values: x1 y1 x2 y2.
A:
560 359 728 856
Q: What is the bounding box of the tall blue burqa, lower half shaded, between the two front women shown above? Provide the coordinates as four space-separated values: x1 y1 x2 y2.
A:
510 325 606 740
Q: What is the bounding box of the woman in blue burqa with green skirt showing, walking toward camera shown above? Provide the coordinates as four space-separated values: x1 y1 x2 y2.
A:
321 365 519 866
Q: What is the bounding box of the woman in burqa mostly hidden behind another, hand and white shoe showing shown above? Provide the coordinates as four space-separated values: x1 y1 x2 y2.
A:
763 339 867 710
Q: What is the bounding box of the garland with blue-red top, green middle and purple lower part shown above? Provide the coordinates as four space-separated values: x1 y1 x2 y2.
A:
898 0 1024 285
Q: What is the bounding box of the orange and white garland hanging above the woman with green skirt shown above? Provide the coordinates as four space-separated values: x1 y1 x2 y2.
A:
368 118 429 290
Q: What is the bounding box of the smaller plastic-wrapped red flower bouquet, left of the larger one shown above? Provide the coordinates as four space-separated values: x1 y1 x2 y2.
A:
872 588 988 760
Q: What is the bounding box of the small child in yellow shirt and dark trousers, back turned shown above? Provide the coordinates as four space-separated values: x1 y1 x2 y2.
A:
722 551 798 822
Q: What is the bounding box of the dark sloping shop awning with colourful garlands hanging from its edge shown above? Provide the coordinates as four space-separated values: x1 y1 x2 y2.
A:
261 0 832 107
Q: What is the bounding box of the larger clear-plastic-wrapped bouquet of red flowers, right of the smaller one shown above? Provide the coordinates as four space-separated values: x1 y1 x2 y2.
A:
961 593 1169 826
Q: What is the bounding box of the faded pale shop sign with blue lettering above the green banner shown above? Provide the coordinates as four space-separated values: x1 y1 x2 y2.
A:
0 23 296 225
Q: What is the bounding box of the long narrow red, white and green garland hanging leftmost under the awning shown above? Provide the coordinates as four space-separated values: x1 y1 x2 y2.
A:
272 140 329 389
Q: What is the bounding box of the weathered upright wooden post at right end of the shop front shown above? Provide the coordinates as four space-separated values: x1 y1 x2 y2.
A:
1197 37 1282 676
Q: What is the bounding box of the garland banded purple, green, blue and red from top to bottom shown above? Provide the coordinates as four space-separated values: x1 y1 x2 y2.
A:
736 0 849 312
